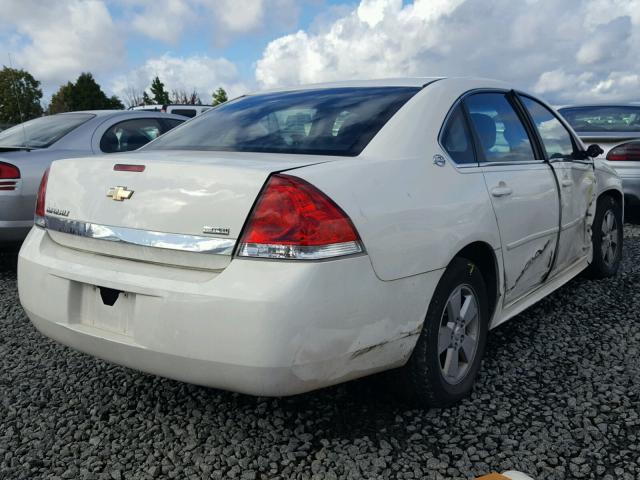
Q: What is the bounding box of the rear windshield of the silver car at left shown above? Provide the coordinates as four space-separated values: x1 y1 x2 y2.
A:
0 113 95 148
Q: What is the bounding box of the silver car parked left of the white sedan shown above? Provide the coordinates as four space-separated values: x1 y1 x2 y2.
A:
0 110 187 244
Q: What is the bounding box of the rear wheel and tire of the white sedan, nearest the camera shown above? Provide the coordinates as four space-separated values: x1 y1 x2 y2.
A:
402 258 489 408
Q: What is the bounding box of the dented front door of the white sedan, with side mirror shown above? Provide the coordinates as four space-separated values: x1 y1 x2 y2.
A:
519 95 596 272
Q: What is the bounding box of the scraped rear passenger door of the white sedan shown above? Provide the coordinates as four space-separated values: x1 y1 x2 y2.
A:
464 91 560 304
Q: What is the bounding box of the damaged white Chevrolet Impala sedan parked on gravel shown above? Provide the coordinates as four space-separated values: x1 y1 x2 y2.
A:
18 78 623 406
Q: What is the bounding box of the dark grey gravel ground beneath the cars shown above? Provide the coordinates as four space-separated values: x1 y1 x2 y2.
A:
0 226 640 480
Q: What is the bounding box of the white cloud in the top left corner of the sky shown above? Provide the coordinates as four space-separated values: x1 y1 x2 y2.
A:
1 0 125 84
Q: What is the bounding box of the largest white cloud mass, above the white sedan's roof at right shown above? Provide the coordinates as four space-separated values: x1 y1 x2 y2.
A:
255 0 640 102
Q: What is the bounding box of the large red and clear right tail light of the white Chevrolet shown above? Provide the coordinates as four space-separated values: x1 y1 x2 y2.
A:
238 174 363 260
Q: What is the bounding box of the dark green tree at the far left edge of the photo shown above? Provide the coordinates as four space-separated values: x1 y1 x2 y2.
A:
0 67 42 123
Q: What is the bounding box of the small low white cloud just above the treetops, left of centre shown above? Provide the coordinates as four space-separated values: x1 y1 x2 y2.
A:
111 54 250 103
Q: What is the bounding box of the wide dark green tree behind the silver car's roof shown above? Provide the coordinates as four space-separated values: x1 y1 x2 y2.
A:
49 72 124 113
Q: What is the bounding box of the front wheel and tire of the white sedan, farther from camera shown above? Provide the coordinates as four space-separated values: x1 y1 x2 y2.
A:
587 195 624 278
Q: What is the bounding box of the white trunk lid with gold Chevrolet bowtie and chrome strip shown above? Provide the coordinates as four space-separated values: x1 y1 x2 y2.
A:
45 151 327 269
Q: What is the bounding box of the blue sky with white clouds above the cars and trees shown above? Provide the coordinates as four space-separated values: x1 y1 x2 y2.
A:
0 0 640 104
